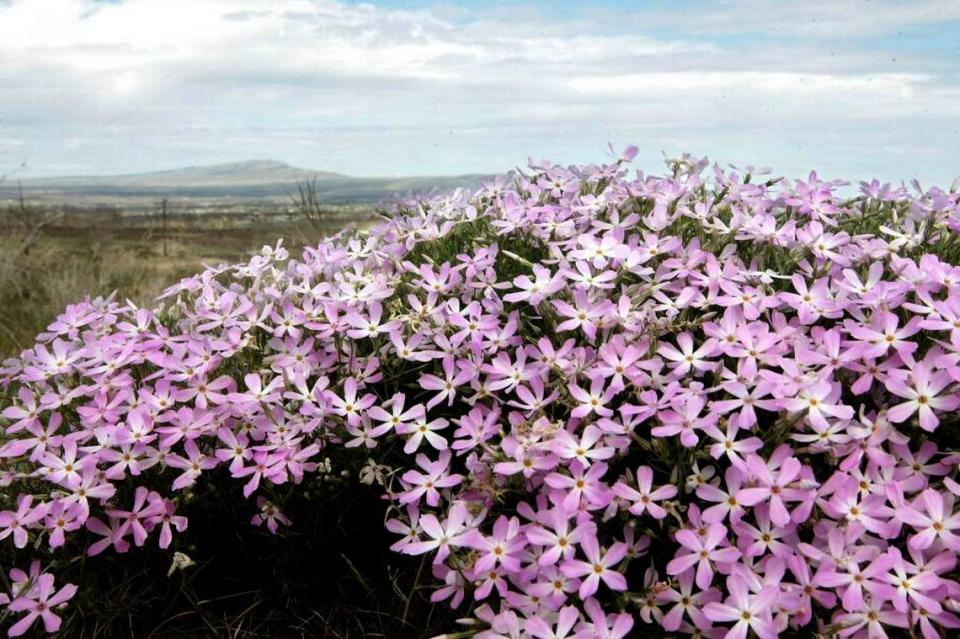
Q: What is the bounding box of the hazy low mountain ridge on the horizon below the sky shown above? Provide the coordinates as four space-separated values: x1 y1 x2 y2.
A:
0 160 485 202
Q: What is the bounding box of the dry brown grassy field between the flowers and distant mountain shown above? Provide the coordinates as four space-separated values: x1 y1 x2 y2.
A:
0 198 373 359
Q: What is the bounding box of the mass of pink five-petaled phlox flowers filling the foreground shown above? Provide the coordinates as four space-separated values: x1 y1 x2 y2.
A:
0 147 960 639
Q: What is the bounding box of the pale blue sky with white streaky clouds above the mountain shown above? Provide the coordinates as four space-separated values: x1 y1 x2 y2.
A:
0 0 960 186
